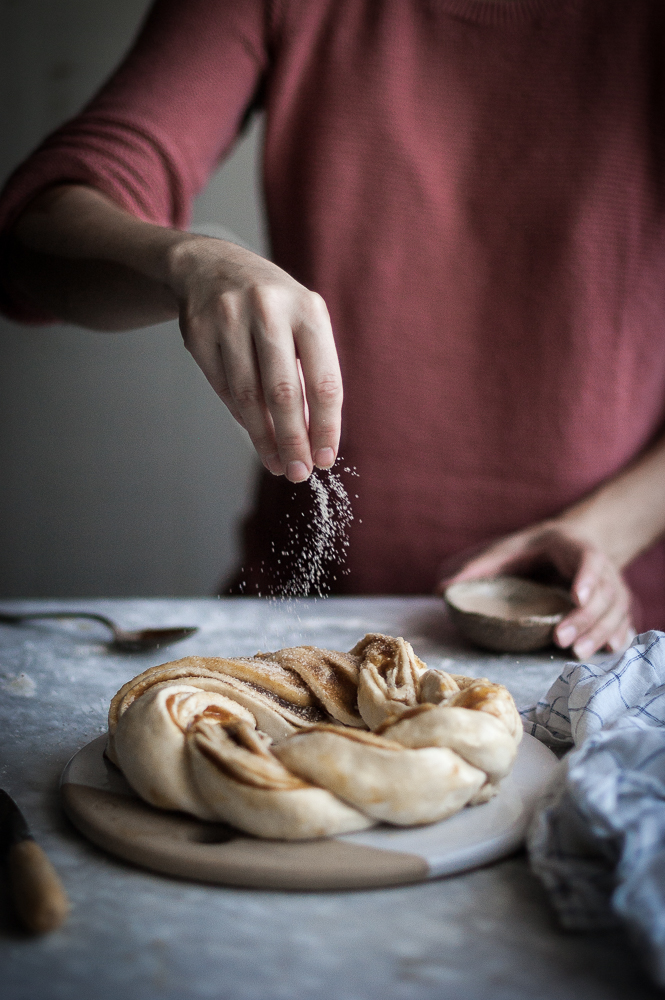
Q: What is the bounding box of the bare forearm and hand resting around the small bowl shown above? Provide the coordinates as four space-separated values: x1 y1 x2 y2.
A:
437 434 665 659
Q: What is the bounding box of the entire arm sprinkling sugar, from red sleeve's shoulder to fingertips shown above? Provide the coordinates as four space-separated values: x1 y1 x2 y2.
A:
0 0 342 481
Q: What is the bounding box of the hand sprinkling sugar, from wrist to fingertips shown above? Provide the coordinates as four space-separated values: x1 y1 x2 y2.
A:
171 237 342 483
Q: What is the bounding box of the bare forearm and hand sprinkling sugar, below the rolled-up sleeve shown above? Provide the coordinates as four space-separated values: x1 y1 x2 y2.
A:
4 184 342 482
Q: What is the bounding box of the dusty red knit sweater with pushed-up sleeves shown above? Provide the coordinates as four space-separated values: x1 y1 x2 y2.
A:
0 0 665 627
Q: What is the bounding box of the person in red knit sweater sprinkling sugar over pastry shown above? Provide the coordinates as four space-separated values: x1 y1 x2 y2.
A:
0 0 665 657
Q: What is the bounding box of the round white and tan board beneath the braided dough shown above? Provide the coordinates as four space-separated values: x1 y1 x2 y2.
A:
60 735 558 889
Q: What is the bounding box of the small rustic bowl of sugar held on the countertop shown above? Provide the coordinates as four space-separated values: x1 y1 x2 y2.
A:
444 576 573 653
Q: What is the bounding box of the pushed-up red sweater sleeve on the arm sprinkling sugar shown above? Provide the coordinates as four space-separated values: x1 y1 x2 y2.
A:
0 0 268 322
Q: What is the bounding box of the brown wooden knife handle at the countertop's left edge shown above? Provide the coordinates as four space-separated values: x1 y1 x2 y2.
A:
7 838 69 934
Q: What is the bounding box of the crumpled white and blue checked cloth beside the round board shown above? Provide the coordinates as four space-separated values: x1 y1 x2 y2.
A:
521 632 665 986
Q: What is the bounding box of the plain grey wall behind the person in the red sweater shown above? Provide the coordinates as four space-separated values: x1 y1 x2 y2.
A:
0 0 266 597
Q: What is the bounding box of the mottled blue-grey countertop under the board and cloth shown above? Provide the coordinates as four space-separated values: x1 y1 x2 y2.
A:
0 598 662 1000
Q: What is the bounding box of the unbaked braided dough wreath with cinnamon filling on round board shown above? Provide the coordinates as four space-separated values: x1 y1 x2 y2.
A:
107 634 522 840
